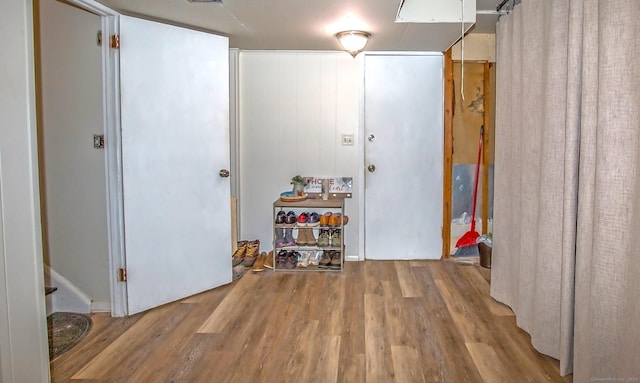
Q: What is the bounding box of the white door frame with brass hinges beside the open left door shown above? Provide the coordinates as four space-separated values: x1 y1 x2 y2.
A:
67 0 128 317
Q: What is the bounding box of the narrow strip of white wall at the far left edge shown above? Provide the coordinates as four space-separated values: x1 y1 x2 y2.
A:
0 0 49 383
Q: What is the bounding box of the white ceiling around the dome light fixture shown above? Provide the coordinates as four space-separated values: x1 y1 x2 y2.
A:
98 0 500 52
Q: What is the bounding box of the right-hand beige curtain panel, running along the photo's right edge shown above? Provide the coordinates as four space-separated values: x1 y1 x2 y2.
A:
574 0 640 382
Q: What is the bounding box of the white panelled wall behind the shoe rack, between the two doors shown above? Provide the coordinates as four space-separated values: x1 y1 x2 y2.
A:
239 51 362 257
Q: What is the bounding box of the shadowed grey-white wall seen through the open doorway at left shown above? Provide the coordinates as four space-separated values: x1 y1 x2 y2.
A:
39 0 110 311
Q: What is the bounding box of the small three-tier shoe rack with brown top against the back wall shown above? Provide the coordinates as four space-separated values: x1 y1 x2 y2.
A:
271 198 345 272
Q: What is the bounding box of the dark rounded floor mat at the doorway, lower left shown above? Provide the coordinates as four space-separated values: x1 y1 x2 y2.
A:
47 312 91 360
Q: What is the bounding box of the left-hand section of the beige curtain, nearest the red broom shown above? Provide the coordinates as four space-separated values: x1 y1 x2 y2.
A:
492 1 577 373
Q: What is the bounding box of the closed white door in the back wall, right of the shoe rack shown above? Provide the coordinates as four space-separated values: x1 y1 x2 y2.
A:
364 54 444 259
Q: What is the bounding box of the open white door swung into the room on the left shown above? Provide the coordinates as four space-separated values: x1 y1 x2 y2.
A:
120 16 232 315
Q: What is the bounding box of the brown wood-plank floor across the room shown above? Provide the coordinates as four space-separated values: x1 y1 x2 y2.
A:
51 261 572 383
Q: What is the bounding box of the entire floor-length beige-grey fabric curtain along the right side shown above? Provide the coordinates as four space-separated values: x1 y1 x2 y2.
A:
491 0 640 382
